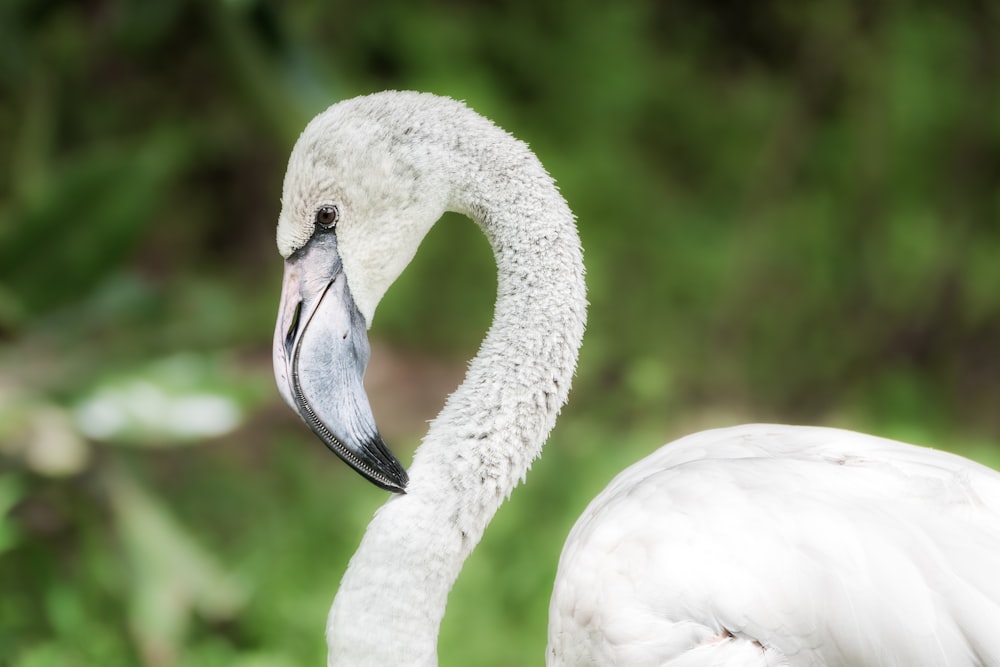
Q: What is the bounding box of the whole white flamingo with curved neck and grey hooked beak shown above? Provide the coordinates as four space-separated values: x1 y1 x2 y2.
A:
274 92 1000 666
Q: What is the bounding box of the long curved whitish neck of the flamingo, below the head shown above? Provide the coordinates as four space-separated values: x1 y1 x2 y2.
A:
327 124 586 665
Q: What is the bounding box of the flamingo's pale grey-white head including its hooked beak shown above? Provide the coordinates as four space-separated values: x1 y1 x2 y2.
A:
273 93 464 492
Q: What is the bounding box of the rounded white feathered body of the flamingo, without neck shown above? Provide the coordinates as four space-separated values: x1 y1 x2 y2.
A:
549 425 1000 666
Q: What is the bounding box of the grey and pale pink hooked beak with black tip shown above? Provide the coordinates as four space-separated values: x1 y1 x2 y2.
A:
273 233 407 493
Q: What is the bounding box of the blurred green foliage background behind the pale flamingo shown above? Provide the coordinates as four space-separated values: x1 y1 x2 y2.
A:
0 0 1000 667
